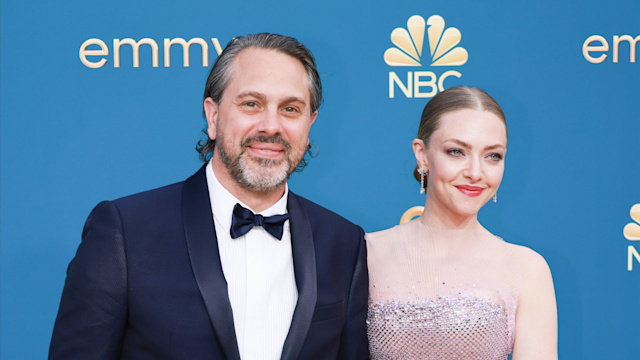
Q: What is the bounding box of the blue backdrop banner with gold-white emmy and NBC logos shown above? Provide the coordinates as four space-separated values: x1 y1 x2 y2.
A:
0 0 640 360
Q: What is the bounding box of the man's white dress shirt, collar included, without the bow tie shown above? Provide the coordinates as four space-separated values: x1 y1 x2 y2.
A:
206 163 298 360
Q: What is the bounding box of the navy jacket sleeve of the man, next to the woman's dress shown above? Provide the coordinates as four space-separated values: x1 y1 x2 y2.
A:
338 228 369 360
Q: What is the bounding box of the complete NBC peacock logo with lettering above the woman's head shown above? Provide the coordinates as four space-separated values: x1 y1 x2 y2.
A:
384 15 469 98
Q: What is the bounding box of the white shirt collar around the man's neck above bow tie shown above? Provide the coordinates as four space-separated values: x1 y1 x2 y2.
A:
205 161 289 232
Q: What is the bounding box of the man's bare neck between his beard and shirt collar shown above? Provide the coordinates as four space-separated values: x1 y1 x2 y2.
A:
210 157 286 213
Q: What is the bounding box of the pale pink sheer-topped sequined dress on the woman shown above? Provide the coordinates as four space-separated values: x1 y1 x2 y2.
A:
367 220 522 360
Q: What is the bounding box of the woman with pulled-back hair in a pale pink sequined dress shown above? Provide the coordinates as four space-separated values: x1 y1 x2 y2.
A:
367 86 558 360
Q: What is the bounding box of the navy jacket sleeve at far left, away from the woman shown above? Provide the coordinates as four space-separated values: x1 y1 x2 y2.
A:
49 202 127 360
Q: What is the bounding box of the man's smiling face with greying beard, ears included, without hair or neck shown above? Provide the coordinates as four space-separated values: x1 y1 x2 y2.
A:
205 48 317 192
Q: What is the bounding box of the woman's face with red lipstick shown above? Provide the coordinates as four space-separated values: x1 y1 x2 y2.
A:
414 109 507 218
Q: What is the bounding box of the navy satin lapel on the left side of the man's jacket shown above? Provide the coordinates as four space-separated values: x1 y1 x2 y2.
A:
182 167 240 360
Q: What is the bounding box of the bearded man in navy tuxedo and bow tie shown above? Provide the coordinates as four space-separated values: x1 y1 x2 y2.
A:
49 34 368 360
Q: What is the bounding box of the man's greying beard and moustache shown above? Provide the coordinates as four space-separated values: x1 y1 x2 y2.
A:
216 133 305 192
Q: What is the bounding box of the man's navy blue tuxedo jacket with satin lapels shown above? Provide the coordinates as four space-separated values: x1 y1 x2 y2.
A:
49 167 369 360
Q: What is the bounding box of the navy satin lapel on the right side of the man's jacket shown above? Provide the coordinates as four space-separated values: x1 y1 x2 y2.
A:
281 191 318 360
